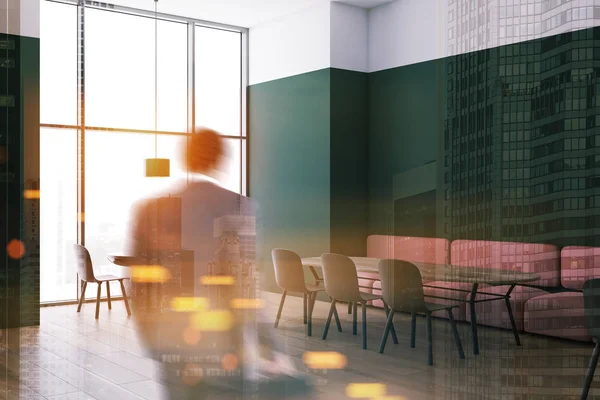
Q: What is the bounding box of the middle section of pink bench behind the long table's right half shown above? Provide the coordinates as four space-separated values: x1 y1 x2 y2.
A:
451 240 560 331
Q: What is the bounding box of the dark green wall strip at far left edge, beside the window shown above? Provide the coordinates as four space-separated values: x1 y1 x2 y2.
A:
0 34 40 328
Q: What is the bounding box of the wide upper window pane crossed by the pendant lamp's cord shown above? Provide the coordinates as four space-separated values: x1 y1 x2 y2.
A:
86 9 187 132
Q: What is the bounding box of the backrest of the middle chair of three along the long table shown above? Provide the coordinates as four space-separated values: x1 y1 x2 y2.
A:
321 253 362 302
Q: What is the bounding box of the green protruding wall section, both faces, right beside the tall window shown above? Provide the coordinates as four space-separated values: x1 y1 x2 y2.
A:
248 68 368 290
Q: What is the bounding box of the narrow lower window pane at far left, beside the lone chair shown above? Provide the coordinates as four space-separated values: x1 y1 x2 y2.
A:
40 128 77 302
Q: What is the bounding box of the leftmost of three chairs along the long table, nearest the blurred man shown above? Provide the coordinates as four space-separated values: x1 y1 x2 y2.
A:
271 249 342 336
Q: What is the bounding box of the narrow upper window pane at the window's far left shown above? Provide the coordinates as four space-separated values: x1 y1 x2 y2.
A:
40 1 77 125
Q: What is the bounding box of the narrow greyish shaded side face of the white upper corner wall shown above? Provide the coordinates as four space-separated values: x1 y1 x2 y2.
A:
331 2 369 72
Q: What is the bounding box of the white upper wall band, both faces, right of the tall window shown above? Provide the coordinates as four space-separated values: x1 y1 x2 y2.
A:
249 1 369 85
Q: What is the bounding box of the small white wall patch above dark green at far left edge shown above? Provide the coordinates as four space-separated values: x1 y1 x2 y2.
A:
0 0 40 38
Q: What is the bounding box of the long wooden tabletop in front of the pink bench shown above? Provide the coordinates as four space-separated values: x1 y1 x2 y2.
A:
302 257 540 286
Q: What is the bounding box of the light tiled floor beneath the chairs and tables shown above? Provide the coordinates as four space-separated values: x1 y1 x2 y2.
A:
0 294 600 400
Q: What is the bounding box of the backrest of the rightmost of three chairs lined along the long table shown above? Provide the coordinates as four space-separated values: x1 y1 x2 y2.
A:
379 260 427 312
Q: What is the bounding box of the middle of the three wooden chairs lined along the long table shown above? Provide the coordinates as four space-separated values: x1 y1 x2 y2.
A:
321 253 398 350
